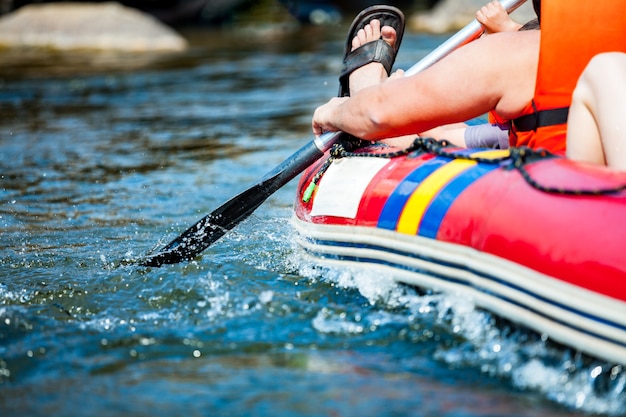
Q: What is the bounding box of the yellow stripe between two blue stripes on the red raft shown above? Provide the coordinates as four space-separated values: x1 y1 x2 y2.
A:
396 150 509 235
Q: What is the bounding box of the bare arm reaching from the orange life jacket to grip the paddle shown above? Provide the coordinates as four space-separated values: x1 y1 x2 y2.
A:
312 31 539 140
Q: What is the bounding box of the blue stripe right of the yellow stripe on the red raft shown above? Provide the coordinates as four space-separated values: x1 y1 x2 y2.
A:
417 164 499 239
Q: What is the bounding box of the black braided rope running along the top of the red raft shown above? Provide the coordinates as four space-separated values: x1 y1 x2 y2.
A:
302 137 626 203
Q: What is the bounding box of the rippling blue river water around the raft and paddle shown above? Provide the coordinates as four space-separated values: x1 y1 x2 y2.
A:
0 22 626 417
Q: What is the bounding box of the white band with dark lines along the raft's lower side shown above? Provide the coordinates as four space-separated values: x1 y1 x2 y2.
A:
292 216 626 365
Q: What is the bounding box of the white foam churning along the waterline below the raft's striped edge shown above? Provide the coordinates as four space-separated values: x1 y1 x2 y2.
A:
290 252 626 416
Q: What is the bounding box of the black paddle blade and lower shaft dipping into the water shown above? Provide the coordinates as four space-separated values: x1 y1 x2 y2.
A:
140 137 324 267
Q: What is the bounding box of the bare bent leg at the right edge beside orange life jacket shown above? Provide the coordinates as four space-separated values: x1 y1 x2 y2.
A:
566 52 626 171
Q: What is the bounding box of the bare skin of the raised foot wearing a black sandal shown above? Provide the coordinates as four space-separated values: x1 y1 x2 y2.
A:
350 19 397 95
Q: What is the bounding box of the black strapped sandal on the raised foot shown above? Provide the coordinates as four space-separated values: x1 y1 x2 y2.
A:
339 5 404 97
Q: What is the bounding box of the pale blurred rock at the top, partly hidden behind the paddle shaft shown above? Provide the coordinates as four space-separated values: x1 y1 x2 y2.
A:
407 0 537 33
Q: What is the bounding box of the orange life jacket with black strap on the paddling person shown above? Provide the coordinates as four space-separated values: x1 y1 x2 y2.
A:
509 0 626 154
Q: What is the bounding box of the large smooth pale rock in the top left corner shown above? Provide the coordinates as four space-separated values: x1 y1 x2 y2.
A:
0 2 187 52
